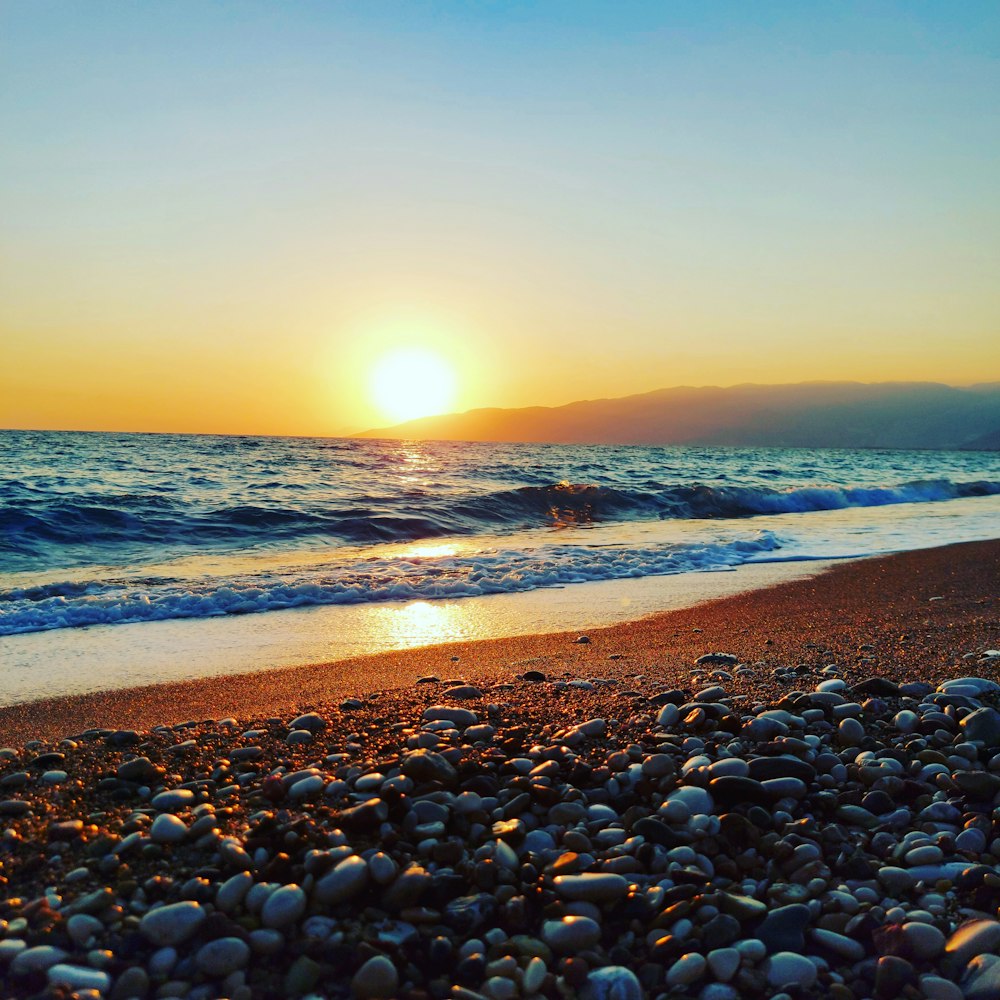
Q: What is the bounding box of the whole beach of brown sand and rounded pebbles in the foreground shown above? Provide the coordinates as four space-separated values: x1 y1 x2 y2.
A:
0 542 1000 1000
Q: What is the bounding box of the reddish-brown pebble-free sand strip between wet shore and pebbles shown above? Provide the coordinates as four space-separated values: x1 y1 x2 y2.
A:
0 540 1000 743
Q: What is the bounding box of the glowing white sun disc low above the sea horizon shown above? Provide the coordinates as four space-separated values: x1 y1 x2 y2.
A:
371 348 455 421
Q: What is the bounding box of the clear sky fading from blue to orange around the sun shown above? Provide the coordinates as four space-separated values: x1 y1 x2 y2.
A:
0 0 1000 434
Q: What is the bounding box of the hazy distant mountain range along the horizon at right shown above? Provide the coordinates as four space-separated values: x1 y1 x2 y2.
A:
356 382 1000 451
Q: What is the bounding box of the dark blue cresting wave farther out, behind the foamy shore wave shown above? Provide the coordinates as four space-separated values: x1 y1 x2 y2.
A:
0 479 1000 569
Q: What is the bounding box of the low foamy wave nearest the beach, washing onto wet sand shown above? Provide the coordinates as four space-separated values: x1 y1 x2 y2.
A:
0 532 781 636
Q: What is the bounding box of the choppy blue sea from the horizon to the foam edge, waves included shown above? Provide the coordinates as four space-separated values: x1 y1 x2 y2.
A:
0 431 1000 635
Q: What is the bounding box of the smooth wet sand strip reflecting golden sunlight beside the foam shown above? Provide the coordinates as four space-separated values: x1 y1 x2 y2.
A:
0 559 839 709
